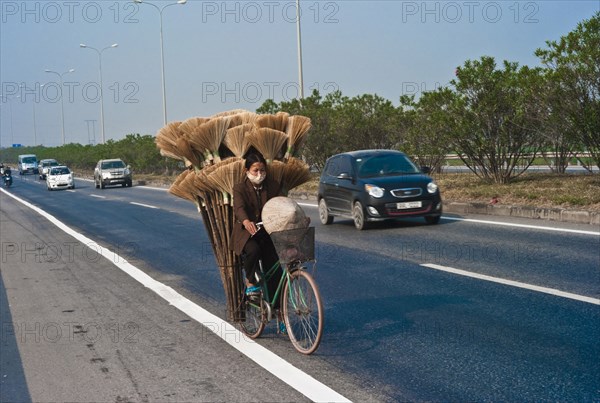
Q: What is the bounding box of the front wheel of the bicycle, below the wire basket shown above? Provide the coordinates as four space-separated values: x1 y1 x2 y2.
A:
282 270 323 354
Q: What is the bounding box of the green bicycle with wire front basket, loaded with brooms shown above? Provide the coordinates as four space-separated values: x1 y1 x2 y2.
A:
240 227 324 355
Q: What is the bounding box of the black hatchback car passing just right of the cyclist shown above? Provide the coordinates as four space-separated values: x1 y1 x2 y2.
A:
318 150 442 230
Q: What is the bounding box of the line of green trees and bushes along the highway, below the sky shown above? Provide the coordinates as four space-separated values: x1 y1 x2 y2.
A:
0 12 600 183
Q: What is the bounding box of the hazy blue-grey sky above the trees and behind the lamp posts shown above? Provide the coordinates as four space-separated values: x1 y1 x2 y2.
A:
0 0 600 147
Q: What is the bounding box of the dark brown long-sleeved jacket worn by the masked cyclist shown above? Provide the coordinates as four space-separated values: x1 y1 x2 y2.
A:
231 176 283 255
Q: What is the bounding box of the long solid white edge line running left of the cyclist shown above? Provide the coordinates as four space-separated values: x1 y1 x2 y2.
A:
0 189 350 402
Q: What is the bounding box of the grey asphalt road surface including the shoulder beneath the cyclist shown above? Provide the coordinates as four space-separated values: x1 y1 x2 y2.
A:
0 177 600 402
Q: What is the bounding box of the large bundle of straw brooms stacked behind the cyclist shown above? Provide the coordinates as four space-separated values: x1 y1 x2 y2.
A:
156 110 311 321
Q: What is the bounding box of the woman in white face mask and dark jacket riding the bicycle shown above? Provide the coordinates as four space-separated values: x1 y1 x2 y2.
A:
232 154 282 296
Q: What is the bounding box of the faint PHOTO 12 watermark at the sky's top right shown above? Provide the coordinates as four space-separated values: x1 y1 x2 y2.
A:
401 1 540 24
